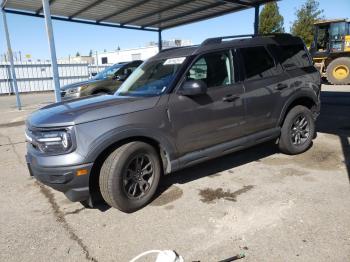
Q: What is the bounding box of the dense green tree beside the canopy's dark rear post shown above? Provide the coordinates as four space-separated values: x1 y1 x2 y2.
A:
259 2 284 34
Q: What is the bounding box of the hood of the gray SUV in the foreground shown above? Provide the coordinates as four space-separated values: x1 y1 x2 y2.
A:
27 95 160 127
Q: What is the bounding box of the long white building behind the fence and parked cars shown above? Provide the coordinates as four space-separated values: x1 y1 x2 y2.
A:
97 39 192 65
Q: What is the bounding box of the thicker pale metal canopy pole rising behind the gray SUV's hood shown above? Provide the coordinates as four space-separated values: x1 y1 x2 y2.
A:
42 0 61 102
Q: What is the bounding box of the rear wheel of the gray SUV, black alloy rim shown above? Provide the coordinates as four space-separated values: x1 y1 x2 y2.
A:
278 105 315 155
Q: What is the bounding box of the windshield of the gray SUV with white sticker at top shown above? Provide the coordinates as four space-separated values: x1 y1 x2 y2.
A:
116 57 185 96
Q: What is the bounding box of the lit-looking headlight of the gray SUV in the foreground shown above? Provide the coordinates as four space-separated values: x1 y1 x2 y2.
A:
26 128 73 154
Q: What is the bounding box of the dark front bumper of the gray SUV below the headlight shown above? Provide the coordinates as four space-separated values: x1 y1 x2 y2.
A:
26 154 93 202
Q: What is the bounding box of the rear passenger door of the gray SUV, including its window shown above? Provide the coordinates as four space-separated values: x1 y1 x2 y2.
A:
239 46 291 134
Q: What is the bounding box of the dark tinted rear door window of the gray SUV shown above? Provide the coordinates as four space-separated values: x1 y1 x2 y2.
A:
240 46 278 80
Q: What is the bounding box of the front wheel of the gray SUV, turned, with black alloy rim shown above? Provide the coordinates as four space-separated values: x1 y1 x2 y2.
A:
99 142 161 213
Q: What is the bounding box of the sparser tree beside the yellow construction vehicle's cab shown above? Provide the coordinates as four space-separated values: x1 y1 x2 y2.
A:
291 0 323 46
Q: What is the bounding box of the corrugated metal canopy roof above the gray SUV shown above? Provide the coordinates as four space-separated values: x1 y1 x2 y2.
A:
2 0 271 30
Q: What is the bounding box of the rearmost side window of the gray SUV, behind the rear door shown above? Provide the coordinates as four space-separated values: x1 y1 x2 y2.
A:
277 45 311 70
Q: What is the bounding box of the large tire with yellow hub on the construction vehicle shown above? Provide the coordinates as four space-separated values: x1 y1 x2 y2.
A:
326 57 350 85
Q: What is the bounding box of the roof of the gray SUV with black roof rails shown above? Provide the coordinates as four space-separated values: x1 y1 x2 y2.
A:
151 34 303 60
